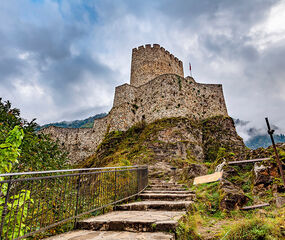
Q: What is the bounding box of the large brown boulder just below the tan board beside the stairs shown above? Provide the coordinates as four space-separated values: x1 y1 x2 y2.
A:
220 179 249 210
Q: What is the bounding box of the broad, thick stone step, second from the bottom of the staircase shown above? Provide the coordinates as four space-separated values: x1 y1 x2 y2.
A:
77 211 185 232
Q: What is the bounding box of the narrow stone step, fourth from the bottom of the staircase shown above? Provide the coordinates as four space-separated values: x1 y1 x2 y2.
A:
139 193 195 201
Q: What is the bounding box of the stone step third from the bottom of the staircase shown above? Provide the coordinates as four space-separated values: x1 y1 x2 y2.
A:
116 201 193 211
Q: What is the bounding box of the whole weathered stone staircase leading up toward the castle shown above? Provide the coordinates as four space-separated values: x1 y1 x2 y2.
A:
46 180 195 240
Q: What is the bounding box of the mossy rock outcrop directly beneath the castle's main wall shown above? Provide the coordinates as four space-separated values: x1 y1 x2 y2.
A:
81 116 245 180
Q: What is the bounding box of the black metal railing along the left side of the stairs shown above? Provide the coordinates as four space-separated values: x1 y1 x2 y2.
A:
0 166 148 240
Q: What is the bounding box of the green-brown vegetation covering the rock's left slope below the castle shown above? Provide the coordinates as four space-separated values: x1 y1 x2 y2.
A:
79 118 197 167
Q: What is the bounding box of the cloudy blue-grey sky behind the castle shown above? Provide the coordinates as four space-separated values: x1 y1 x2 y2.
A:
0 0 285 137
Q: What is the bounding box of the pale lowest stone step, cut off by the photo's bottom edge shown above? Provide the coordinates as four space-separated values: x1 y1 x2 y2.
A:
45 230 175 240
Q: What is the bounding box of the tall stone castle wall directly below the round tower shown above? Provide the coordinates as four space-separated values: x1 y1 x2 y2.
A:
108 74 228 130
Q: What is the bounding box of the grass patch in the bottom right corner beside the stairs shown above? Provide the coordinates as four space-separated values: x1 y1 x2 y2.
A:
176 204 285 240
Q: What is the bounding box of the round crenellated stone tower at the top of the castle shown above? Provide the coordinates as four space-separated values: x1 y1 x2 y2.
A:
130 44 184 87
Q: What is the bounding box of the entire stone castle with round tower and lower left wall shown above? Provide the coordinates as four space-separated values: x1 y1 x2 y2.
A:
42 44 228 163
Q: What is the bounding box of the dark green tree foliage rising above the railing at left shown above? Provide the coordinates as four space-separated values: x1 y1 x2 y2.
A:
0 98 68 172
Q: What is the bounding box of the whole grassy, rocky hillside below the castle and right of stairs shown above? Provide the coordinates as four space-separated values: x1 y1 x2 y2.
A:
79 116 285 240
